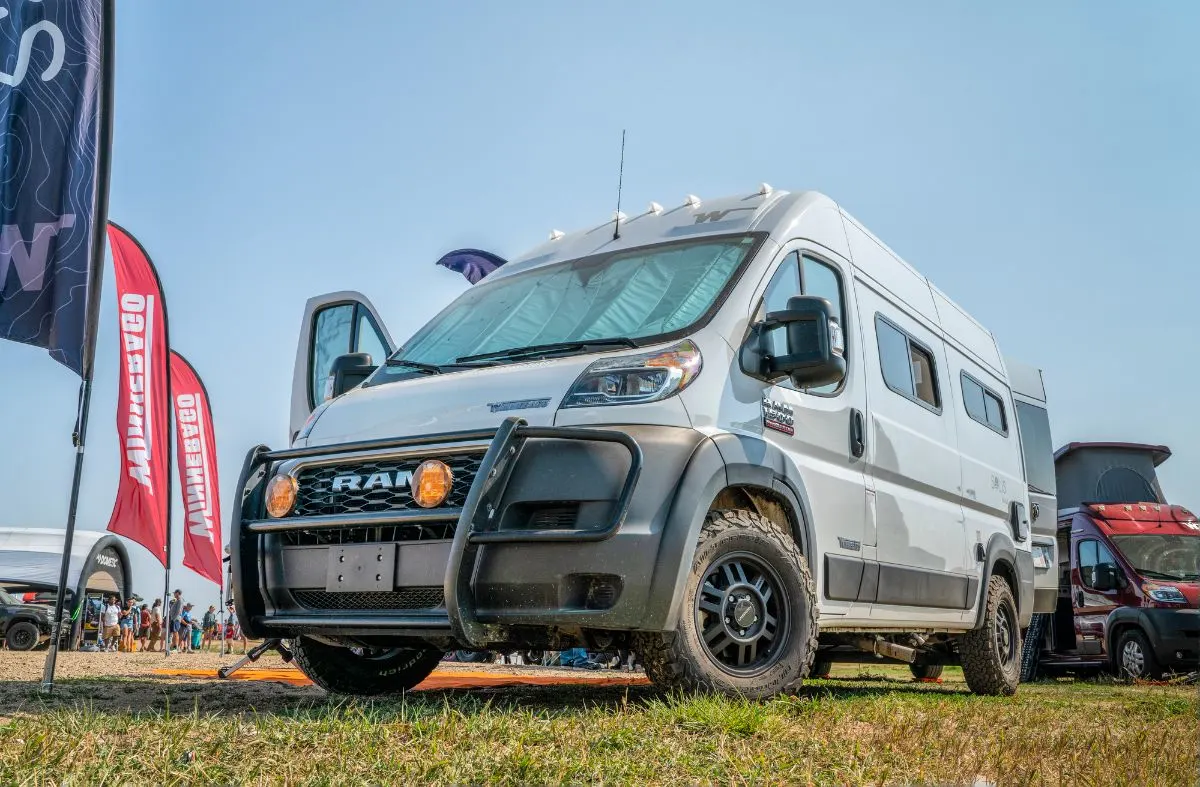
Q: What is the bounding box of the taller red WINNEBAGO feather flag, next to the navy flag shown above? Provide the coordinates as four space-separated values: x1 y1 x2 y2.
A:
108 223 170 565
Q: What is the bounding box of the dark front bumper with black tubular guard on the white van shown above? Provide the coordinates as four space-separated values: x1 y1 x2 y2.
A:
232 419 707 648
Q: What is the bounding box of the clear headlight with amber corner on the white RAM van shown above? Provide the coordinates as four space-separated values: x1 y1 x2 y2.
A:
559 341 702 408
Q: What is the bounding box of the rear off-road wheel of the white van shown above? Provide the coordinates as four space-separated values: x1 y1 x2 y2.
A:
959 576 1021 696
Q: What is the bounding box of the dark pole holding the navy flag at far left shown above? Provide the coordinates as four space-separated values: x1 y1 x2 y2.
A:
42 0 115 693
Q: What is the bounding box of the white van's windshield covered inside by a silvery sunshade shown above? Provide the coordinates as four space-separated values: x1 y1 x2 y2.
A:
368 235 758 385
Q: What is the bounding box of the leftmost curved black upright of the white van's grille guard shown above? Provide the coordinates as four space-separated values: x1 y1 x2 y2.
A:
229 445 270 639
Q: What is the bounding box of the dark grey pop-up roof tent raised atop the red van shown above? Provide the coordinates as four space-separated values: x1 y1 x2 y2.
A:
1054 443 1171 509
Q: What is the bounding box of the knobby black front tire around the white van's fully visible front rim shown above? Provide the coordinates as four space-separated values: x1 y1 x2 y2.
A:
634 510 817 699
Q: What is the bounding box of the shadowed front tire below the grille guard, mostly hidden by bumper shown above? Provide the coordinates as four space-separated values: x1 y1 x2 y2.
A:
292 637 443 697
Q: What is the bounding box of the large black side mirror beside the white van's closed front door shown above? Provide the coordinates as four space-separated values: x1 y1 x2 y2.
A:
738 295 846 388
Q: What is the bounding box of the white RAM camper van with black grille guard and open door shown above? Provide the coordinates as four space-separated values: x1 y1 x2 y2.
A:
232 185 1054 697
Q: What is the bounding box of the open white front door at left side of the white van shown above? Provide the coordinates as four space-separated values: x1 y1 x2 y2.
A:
288 290 396 441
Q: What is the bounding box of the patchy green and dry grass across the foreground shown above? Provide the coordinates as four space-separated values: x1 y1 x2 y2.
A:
0 666 1200 787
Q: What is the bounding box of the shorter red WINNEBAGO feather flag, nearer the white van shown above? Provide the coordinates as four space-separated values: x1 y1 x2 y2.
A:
170 350 222 584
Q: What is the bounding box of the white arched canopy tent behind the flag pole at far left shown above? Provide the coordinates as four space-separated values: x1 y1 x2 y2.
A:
0 528 133 647
